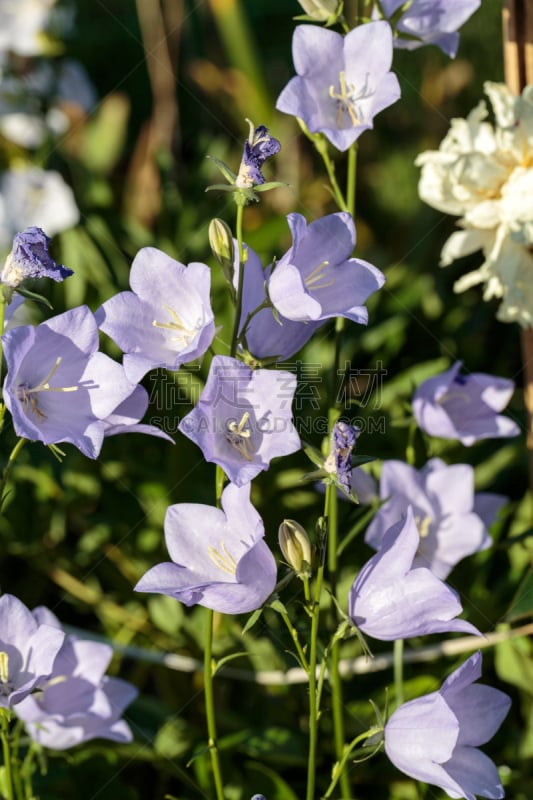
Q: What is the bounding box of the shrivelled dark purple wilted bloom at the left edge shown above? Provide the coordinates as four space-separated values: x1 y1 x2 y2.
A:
0 228 73 289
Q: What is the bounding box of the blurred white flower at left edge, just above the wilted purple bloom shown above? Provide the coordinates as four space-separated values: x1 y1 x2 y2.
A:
0 166 80 249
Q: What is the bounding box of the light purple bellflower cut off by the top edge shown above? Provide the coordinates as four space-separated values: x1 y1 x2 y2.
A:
380 0 481 58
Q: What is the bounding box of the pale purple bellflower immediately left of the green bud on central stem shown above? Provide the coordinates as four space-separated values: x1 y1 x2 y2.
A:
95 247 215 383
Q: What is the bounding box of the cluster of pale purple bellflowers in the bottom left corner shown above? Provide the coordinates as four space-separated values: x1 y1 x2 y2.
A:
0 594 137 750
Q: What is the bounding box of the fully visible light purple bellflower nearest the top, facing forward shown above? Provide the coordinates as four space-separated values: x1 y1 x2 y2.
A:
276 20 400 150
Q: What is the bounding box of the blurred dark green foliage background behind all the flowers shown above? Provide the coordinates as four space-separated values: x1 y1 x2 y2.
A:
0 0 533 800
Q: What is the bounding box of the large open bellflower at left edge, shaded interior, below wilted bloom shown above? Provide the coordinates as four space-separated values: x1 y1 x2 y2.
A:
2 306 144 458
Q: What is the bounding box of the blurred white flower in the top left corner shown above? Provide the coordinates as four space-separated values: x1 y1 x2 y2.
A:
0 0 56 56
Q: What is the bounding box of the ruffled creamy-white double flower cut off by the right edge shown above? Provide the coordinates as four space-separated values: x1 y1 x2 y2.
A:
416 82 533 327
